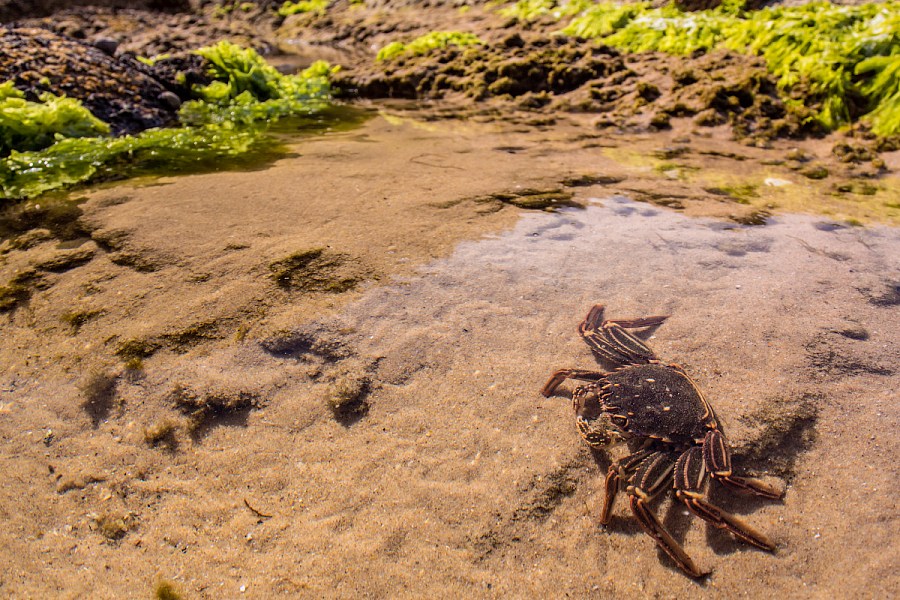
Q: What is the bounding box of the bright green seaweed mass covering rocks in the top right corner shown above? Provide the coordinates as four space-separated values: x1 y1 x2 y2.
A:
562 0 900 136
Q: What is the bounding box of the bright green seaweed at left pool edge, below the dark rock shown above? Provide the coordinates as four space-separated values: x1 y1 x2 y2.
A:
0 42 336 198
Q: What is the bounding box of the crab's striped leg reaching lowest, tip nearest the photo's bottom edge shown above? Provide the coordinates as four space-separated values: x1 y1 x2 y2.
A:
607 452 705 577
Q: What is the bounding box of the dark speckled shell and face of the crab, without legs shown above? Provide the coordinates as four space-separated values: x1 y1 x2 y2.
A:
572 363 718 447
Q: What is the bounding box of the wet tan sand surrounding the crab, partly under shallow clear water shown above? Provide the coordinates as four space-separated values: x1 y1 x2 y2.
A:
0 111 900 598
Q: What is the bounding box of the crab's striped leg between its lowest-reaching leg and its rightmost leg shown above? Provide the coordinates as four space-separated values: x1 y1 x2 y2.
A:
675 446 775 552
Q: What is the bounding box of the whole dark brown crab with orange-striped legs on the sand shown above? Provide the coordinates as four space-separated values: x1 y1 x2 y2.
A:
541 304 782 577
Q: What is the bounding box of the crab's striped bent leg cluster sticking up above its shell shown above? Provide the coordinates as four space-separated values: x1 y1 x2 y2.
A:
578 304 668 365
